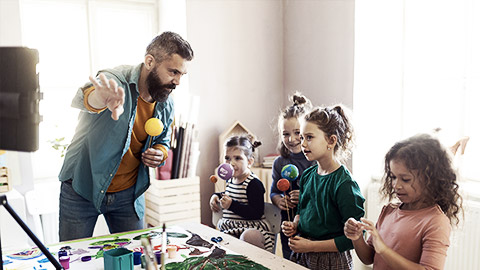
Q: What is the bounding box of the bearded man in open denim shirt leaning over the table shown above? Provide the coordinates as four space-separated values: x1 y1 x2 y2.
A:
59 32 193 241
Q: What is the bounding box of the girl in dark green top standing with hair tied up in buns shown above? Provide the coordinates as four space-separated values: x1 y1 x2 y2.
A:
282 105 365 269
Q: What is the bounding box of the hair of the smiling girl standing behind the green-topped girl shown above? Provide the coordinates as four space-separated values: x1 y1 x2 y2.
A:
277 92 311 158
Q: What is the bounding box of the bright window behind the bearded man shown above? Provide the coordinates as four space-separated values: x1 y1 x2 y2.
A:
20 0 158 181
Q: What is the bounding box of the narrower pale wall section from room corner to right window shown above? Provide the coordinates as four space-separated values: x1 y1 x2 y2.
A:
284 0 355 109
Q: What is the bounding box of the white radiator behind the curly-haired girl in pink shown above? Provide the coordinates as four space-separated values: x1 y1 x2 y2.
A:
366 180 480 270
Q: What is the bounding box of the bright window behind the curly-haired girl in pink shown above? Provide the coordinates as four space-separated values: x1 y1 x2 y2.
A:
354 0 480 184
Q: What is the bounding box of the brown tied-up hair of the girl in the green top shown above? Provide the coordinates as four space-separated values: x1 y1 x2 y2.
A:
305 104 354 162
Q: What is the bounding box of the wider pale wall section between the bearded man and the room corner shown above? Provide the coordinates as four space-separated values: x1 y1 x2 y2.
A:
187 0 284 224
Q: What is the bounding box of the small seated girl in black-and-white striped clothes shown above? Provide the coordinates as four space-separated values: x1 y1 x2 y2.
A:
210 135 274 252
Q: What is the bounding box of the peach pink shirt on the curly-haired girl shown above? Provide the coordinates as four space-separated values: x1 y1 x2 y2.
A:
368 204 451 270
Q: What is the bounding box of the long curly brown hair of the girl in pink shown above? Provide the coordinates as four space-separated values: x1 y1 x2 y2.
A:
381 134 463 224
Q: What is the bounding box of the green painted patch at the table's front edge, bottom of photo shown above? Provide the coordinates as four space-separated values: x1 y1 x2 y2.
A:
165 254 268 270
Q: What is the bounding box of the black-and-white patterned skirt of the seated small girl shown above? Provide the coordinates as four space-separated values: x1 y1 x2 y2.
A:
217 218 275 252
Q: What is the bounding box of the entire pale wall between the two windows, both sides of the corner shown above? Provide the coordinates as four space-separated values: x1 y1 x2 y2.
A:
187 0 354 224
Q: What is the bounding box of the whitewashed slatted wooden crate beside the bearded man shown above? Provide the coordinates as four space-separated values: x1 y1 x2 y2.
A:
145 176 200 227
